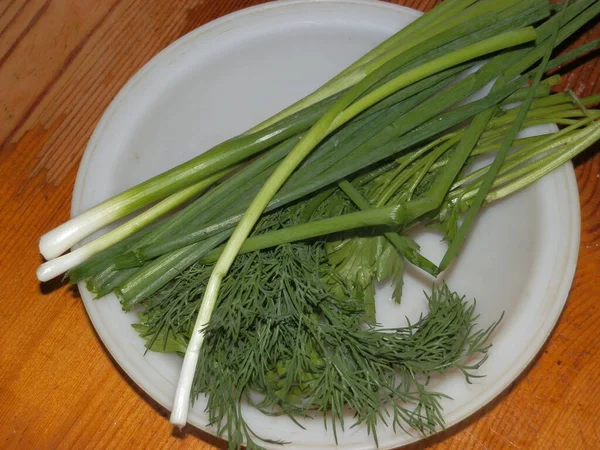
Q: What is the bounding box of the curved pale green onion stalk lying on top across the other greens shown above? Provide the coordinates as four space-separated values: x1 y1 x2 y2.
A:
170 27 536 427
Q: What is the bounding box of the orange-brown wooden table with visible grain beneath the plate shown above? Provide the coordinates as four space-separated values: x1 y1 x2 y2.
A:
0 0 600 450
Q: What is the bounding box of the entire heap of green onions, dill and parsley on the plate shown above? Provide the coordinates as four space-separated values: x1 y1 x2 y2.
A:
38 0 600 448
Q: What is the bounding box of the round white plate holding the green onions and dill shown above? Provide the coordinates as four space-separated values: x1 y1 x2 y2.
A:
72 0 579 449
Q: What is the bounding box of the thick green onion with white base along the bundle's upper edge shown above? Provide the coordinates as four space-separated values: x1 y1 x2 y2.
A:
39 0 500 259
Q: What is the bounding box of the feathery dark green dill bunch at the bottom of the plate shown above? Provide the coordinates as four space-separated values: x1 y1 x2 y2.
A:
136 229 496 448
